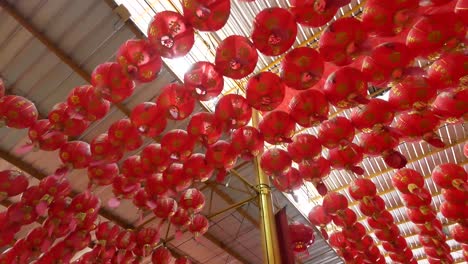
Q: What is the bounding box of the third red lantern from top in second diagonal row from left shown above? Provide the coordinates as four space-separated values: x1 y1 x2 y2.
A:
215 35 258 79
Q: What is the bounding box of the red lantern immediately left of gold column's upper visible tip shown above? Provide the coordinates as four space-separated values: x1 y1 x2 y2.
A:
215 94 252 130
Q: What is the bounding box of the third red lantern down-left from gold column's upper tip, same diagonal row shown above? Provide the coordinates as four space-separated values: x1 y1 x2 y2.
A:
161 129 195 162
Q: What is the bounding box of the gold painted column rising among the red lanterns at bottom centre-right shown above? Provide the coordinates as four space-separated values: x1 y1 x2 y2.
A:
252 110 281 264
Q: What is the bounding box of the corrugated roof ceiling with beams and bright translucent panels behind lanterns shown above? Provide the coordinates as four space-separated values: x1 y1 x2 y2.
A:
0 0 468 264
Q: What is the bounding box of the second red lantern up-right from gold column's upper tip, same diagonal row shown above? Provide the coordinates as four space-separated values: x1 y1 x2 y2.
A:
281 47 324 90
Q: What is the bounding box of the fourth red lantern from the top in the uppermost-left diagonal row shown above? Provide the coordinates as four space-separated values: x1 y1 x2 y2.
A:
91 62 135 103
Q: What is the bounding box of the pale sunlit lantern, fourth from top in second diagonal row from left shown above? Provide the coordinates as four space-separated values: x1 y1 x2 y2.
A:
184 61 224 101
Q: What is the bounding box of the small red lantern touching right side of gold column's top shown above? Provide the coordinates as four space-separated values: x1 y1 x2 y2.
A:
260 148 292 175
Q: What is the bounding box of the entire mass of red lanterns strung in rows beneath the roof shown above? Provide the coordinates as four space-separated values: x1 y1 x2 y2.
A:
0 0 468 263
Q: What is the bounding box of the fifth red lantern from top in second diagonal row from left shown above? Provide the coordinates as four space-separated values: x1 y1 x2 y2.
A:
156 83 195 120
